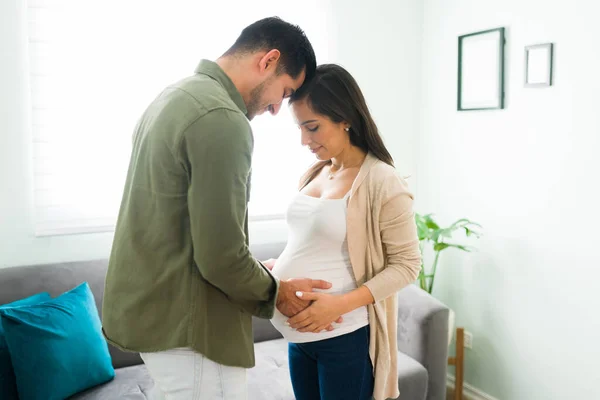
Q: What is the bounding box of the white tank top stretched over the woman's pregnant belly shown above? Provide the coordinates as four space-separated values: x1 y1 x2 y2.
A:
271 193 369 343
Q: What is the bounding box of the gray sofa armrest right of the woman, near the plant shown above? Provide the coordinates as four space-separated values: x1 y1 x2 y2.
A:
398 285 449 400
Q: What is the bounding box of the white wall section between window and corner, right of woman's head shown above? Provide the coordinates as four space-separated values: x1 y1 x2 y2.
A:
322 0 423 181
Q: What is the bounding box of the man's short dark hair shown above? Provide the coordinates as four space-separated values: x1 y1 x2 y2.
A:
224 17 317 81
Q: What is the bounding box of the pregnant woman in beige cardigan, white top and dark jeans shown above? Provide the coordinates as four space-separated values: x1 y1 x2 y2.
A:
265 65 421 400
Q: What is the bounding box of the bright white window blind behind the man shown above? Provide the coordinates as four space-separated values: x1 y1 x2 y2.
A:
28 0 327 235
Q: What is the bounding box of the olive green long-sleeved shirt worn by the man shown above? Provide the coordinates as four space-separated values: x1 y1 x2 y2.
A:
102 60 278 368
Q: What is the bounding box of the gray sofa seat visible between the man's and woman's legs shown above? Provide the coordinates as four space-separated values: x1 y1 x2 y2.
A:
248 339 294 400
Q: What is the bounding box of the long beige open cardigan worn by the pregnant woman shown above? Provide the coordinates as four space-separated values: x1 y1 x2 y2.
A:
300 153 421 400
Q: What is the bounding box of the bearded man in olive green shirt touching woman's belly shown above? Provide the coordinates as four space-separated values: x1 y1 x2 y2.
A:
102 18 330 400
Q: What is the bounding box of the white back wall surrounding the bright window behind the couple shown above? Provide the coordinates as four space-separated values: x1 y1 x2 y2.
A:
0 0 423 267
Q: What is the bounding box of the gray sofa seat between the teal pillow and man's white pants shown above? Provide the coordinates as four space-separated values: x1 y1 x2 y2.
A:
70 364 154 400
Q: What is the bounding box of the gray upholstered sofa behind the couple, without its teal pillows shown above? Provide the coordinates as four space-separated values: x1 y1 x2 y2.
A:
0 245 448 400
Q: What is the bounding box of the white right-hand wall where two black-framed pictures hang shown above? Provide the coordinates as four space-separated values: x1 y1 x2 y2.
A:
416 0 600 400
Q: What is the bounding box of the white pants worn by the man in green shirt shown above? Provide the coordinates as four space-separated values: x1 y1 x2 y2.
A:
141 348 248 400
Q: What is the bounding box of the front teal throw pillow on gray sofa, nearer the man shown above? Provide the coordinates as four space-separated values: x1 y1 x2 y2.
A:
0 282 115 400
